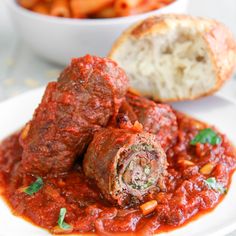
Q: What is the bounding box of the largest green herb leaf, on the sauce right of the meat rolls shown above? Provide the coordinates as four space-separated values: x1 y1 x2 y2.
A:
190 128 221 145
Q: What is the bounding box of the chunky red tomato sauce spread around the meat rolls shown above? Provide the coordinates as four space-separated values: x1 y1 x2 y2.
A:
0 112 236 235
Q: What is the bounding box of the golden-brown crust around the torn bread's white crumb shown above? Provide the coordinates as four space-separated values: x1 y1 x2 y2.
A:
108 14 236 102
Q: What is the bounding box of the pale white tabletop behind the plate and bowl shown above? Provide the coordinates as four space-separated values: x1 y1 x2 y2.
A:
0 0 236 236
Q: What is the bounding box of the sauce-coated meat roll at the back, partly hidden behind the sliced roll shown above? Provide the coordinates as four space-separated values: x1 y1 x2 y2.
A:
125 92 178 151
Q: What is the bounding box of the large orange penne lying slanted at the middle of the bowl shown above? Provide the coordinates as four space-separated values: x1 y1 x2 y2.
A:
70 0 114 18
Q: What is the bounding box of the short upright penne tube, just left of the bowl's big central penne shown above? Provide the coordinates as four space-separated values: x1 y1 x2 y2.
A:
50 0 71 17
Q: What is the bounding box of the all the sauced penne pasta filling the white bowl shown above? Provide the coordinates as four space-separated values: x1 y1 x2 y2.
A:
18 0 175 18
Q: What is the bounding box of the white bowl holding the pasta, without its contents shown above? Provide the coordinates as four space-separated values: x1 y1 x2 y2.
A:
5 0 188 65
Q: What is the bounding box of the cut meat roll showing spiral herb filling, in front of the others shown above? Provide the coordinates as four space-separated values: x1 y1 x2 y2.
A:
83 128 168 207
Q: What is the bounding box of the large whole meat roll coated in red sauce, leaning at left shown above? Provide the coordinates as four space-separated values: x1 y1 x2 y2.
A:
20 55 128 175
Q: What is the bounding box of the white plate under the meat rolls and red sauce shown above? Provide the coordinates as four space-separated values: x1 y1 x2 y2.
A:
0 88 236 236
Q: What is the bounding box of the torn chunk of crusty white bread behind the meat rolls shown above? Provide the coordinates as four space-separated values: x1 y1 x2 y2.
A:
109 14 236 102
